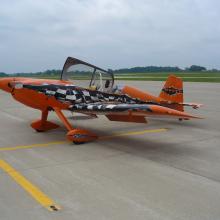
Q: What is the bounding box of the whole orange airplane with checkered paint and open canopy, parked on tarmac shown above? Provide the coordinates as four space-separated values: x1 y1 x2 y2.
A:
0 57 201 144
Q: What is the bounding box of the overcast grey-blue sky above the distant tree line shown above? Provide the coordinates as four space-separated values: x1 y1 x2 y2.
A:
0 0 220 73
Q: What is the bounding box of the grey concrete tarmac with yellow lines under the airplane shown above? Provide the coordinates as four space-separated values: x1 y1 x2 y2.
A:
0 81 220 220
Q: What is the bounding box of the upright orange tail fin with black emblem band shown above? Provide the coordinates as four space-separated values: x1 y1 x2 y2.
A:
159 75 184 111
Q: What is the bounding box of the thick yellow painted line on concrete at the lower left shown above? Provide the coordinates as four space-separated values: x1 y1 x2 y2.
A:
0 160 60 211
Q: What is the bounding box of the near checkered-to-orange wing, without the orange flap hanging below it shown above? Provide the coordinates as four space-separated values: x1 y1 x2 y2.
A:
69 103 199 119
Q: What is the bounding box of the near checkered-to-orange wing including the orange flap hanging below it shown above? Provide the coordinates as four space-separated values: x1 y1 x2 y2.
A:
69 103 201 123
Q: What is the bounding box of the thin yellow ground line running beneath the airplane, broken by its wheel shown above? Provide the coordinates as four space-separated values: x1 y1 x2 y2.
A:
0 128 168 152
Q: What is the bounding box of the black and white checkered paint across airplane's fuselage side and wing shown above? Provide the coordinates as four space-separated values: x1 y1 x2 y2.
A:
18 84 156 114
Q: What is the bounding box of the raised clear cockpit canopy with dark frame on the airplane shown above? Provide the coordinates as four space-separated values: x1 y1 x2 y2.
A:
61 57 114 92
